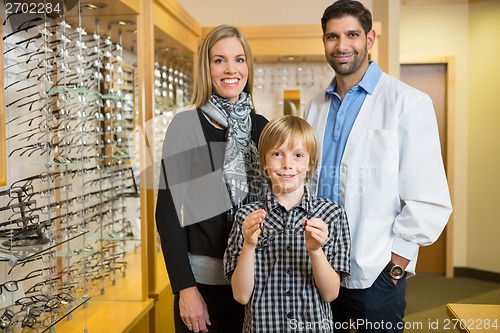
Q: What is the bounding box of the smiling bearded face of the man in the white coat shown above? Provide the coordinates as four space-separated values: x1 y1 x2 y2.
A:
323 16 375 76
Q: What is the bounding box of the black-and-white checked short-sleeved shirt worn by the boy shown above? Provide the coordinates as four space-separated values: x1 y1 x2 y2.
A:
224 187 351 333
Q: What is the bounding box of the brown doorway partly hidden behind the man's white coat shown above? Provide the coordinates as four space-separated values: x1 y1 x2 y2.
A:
400 62 453 276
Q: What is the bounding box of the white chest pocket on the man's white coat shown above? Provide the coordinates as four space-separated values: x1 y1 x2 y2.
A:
363 129 399 171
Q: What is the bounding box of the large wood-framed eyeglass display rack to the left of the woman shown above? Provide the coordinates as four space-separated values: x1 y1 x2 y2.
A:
0 0 200 332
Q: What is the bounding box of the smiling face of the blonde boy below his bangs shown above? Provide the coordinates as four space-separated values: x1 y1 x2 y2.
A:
264 140 309 195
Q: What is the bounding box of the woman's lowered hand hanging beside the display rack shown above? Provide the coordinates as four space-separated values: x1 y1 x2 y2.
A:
179 287 210 332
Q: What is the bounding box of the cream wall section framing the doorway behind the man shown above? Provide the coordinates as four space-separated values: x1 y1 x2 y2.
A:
400 4 469 267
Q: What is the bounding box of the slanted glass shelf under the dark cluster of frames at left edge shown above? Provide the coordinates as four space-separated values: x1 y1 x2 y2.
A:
0 230 89 266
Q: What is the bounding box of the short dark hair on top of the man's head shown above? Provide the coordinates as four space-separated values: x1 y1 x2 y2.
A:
321 0 372 34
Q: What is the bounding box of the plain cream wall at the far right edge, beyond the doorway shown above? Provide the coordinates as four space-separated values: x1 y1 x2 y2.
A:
464 0 500 273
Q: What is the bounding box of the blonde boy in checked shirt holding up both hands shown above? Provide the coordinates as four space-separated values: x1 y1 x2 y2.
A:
224 116 350 333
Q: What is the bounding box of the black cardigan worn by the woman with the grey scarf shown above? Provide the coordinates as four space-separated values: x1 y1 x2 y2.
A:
156 110 267 293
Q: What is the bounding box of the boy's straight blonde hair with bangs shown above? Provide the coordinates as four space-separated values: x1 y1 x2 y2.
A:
259 116 319 181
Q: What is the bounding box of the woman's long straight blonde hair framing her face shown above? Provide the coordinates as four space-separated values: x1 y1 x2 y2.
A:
191 25 253 107
